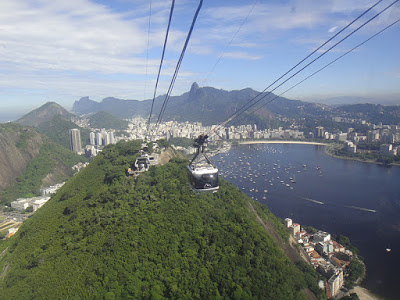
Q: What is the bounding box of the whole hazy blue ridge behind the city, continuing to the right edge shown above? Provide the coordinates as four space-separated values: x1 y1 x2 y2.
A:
73 83 400 128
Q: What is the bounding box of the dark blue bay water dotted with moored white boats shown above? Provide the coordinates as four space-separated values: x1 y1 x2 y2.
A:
214 144 400 299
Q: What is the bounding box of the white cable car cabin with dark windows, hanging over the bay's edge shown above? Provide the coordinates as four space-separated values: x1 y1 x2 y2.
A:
187 164 219 193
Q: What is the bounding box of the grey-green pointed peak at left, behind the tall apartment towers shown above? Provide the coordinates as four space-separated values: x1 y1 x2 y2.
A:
16 102 73 127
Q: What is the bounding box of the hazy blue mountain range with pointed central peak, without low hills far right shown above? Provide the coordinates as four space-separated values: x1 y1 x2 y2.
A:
73 83 330 125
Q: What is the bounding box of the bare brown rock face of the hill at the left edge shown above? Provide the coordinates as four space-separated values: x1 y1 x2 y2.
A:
0 123 44 191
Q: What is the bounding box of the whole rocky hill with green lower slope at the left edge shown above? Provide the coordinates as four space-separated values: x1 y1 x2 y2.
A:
0 123 86 204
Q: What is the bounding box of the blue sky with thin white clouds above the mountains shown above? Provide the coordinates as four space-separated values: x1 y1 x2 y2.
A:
0 0 400 118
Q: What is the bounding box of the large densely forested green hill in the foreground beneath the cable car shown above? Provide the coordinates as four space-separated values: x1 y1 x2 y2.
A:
0 142 315 299
